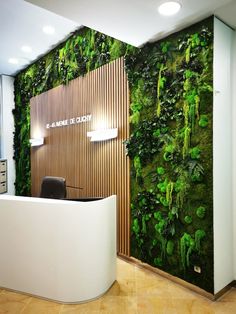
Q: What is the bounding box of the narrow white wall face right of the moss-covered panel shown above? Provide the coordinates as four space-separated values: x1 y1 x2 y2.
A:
213 18 234 293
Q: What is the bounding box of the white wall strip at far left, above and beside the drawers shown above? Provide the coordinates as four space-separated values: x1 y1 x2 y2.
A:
0 75 15 195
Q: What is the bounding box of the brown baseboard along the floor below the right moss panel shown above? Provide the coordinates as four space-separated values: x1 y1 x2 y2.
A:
118 253 236 301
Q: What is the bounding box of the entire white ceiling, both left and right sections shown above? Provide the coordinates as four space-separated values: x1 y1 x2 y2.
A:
0 0 236 75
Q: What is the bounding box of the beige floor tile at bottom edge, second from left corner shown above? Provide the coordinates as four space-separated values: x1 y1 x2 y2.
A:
20 298 62 314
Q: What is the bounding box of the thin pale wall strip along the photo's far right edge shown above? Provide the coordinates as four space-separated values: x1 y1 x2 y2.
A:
231 31 236 280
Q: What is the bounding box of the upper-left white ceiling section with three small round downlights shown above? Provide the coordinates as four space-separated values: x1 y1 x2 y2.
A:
0 0 79 75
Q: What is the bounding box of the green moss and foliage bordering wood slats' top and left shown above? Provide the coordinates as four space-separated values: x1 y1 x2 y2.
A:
13 27 136 195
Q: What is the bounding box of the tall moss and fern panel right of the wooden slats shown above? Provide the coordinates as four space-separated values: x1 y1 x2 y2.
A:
126 18 213 292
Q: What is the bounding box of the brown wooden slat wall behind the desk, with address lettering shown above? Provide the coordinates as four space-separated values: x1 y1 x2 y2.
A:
31 58 130 256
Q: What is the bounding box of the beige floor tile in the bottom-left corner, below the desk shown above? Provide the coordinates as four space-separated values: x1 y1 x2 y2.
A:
0 290 31 314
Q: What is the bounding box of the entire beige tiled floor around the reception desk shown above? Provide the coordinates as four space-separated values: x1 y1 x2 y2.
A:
0 259 236 314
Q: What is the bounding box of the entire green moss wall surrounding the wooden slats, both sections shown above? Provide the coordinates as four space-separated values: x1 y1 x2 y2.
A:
13 18 213 292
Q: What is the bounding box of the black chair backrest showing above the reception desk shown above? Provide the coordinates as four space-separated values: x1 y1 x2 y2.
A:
40 176 66 199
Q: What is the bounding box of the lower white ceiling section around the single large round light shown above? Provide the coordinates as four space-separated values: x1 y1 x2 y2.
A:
26 0 236 46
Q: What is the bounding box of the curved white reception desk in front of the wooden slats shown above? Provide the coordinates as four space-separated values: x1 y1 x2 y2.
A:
0 195 116 303
